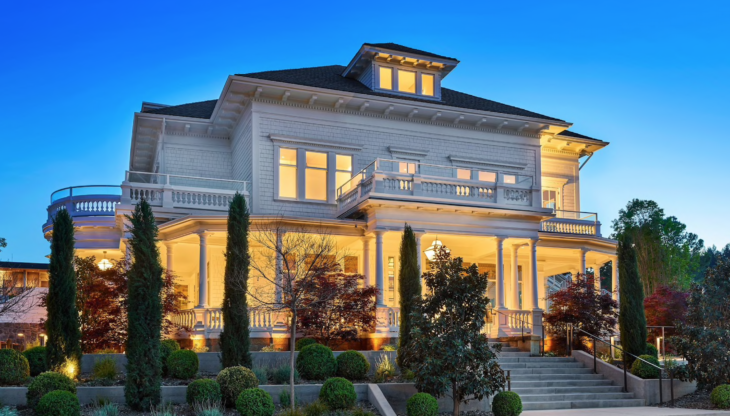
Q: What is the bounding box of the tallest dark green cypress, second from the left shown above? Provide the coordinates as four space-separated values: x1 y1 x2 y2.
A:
124 200 163 410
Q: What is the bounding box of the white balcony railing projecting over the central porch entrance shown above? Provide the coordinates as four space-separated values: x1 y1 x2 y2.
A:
337 159 541 216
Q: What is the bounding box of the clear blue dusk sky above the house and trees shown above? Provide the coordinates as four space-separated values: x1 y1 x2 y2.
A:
0 1 730 262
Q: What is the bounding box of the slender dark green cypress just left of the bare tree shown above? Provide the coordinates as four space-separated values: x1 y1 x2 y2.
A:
220 193 252 368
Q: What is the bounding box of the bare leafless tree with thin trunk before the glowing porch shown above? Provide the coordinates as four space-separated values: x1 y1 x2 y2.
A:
248 219 345 407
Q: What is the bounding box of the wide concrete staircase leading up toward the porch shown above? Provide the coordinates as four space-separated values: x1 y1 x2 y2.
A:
499 345 644 410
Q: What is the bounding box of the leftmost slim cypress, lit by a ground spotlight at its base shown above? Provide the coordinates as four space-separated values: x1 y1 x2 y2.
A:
46 209 81 375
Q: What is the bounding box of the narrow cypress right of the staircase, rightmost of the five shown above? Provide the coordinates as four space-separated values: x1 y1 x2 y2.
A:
618 233 646 367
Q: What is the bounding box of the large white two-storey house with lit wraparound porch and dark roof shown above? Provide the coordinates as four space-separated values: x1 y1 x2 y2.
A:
43 43 618 348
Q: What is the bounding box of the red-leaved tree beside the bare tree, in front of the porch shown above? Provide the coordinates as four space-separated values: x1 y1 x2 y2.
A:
298 271 378 348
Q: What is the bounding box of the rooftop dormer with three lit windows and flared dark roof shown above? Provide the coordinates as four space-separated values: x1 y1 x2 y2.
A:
342 43 459 100
